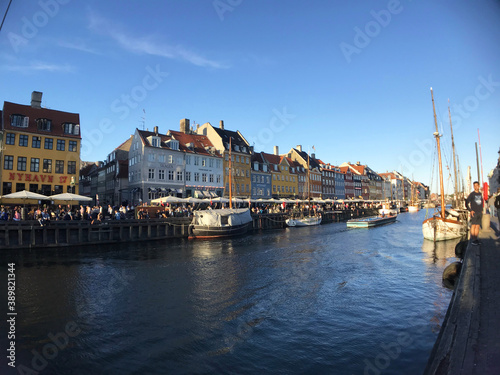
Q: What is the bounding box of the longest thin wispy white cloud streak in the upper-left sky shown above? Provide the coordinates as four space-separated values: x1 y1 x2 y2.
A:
89 14 229 69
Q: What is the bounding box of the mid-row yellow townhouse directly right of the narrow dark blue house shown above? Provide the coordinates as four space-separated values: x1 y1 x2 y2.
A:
261 146 299 199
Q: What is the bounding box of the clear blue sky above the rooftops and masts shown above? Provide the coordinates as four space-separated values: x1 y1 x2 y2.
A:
0 0 500 194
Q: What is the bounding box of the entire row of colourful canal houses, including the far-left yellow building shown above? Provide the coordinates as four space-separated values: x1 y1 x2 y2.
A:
0 92 426 205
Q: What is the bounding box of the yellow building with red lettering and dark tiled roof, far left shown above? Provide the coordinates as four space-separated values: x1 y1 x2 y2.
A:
0 91 81 203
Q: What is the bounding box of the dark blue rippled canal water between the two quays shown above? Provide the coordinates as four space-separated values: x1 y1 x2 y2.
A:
0 210 456 375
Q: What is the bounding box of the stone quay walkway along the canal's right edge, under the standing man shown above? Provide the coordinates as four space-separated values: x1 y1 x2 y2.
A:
425 218 500 375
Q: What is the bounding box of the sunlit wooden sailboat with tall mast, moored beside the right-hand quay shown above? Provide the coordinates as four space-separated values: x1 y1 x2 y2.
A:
422 88 467 241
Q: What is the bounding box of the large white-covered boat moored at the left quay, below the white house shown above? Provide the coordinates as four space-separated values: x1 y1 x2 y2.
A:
189 208 252 238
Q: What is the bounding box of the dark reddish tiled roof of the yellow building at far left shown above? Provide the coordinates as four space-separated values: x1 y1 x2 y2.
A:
2 102 81 139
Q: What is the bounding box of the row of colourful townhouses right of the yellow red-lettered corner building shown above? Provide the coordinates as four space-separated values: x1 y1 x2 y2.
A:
81 119 430 204
